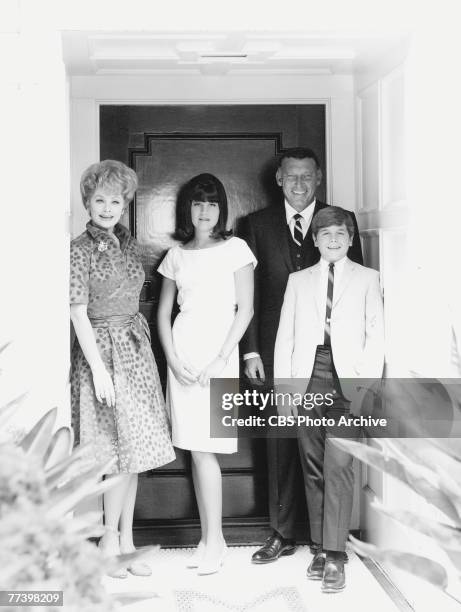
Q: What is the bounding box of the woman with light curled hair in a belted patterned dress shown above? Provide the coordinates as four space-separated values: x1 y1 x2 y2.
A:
70 160 175 578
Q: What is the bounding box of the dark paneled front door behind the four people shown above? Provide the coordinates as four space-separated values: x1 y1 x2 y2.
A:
100 104 326 545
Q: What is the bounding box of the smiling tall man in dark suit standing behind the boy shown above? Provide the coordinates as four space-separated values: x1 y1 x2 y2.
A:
241 148 363 563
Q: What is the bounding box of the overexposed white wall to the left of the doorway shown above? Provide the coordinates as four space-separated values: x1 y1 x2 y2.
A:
0 11 69 429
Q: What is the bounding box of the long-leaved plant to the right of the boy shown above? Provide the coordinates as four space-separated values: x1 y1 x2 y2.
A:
333 380 461 603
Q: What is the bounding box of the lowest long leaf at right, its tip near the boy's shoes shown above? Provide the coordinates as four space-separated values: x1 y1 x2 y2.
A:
349 536 448 591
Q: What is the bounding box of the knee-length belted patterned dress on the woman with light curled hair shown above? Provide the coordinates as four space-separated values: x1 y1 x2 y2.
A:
70 223 175 473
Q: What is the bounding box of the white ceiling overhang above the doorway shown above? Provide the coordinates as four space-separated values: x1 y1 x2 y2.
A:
63 31 409 76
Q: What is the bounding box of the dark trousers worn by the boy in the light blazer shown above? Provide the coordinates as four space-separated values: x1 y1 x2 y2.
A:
298 345 359 551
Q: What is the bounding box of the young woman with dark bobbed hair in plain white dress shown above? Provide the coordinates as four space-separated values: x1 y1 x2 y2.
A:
158 174 256 574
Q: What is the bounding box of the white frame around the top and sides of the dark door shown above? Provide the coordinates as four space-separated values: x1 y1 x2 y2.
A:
70 76 356 236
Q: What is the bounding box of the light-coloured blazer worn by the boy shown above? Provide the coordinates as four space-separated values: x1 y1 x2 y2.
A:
274 259 384 378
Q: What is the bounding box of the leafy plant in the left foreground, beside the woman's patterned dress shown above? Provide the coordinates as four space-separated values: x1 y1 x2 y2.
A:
0 345 155 612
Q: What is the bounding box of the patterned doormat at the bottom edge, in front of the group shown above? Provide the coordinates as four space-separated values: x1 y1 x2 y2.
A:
174 587 308 612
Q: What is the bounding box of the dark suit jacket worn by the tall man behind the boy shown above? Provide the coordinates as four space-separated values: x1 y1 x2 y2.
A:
240 200 363 379
